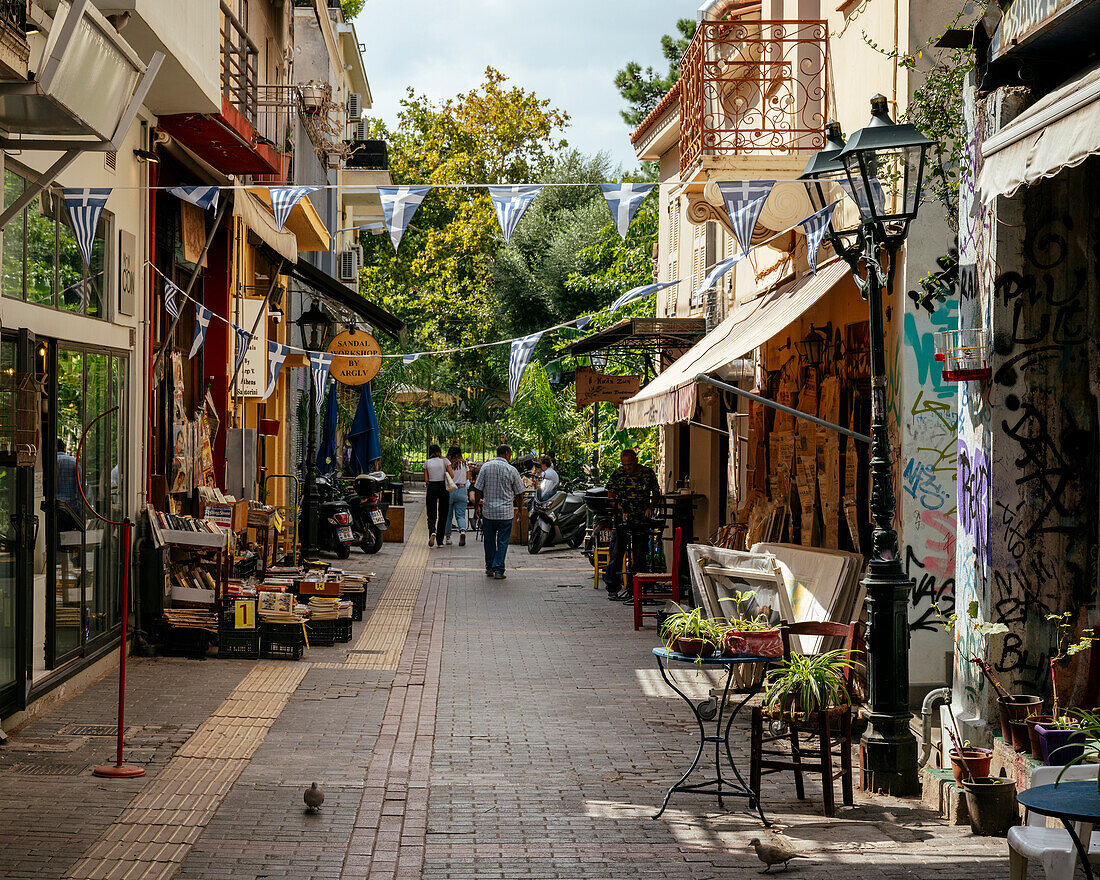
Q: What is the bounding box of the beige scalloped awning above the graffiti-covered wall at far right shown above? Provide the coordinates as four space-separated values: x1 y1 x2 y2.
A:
978 65 1100 202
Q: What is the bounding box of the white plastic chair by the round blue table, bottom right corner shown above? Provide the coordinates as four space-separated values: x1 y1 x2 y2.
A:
1009 763 1100 880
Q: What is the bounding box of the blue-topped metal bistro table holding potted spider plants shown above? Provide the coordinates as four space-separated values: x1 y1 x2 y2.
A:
653 648 776 826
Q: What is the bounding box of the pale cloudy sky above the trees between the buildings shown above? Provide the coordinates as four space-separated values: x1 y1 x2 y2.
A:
347 0 699 169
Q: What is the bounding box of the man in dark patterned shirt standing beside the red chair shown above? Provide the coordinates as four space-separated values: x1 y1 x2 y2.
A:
604 449 661 601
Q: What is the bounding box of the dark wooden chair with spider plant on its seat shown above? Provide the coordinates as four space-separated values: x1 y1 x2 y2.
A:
749 623 861 817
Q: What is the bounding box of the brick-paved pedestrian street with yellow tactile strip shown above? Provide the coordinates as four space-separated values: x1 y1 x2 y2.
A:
0 495 1025 880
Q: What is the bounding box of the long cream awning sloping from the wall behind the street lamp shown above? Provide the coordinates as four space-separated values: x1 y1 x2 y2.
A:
619 260 849 430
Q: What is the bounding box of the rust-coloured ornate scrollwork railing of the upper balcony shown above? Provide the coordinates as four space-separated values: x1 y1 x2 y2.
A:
680 20 828 173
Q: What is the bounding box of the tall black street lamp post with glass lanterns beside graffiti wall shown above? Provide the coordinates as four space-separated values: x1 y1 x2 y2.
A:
803 95 932 795
